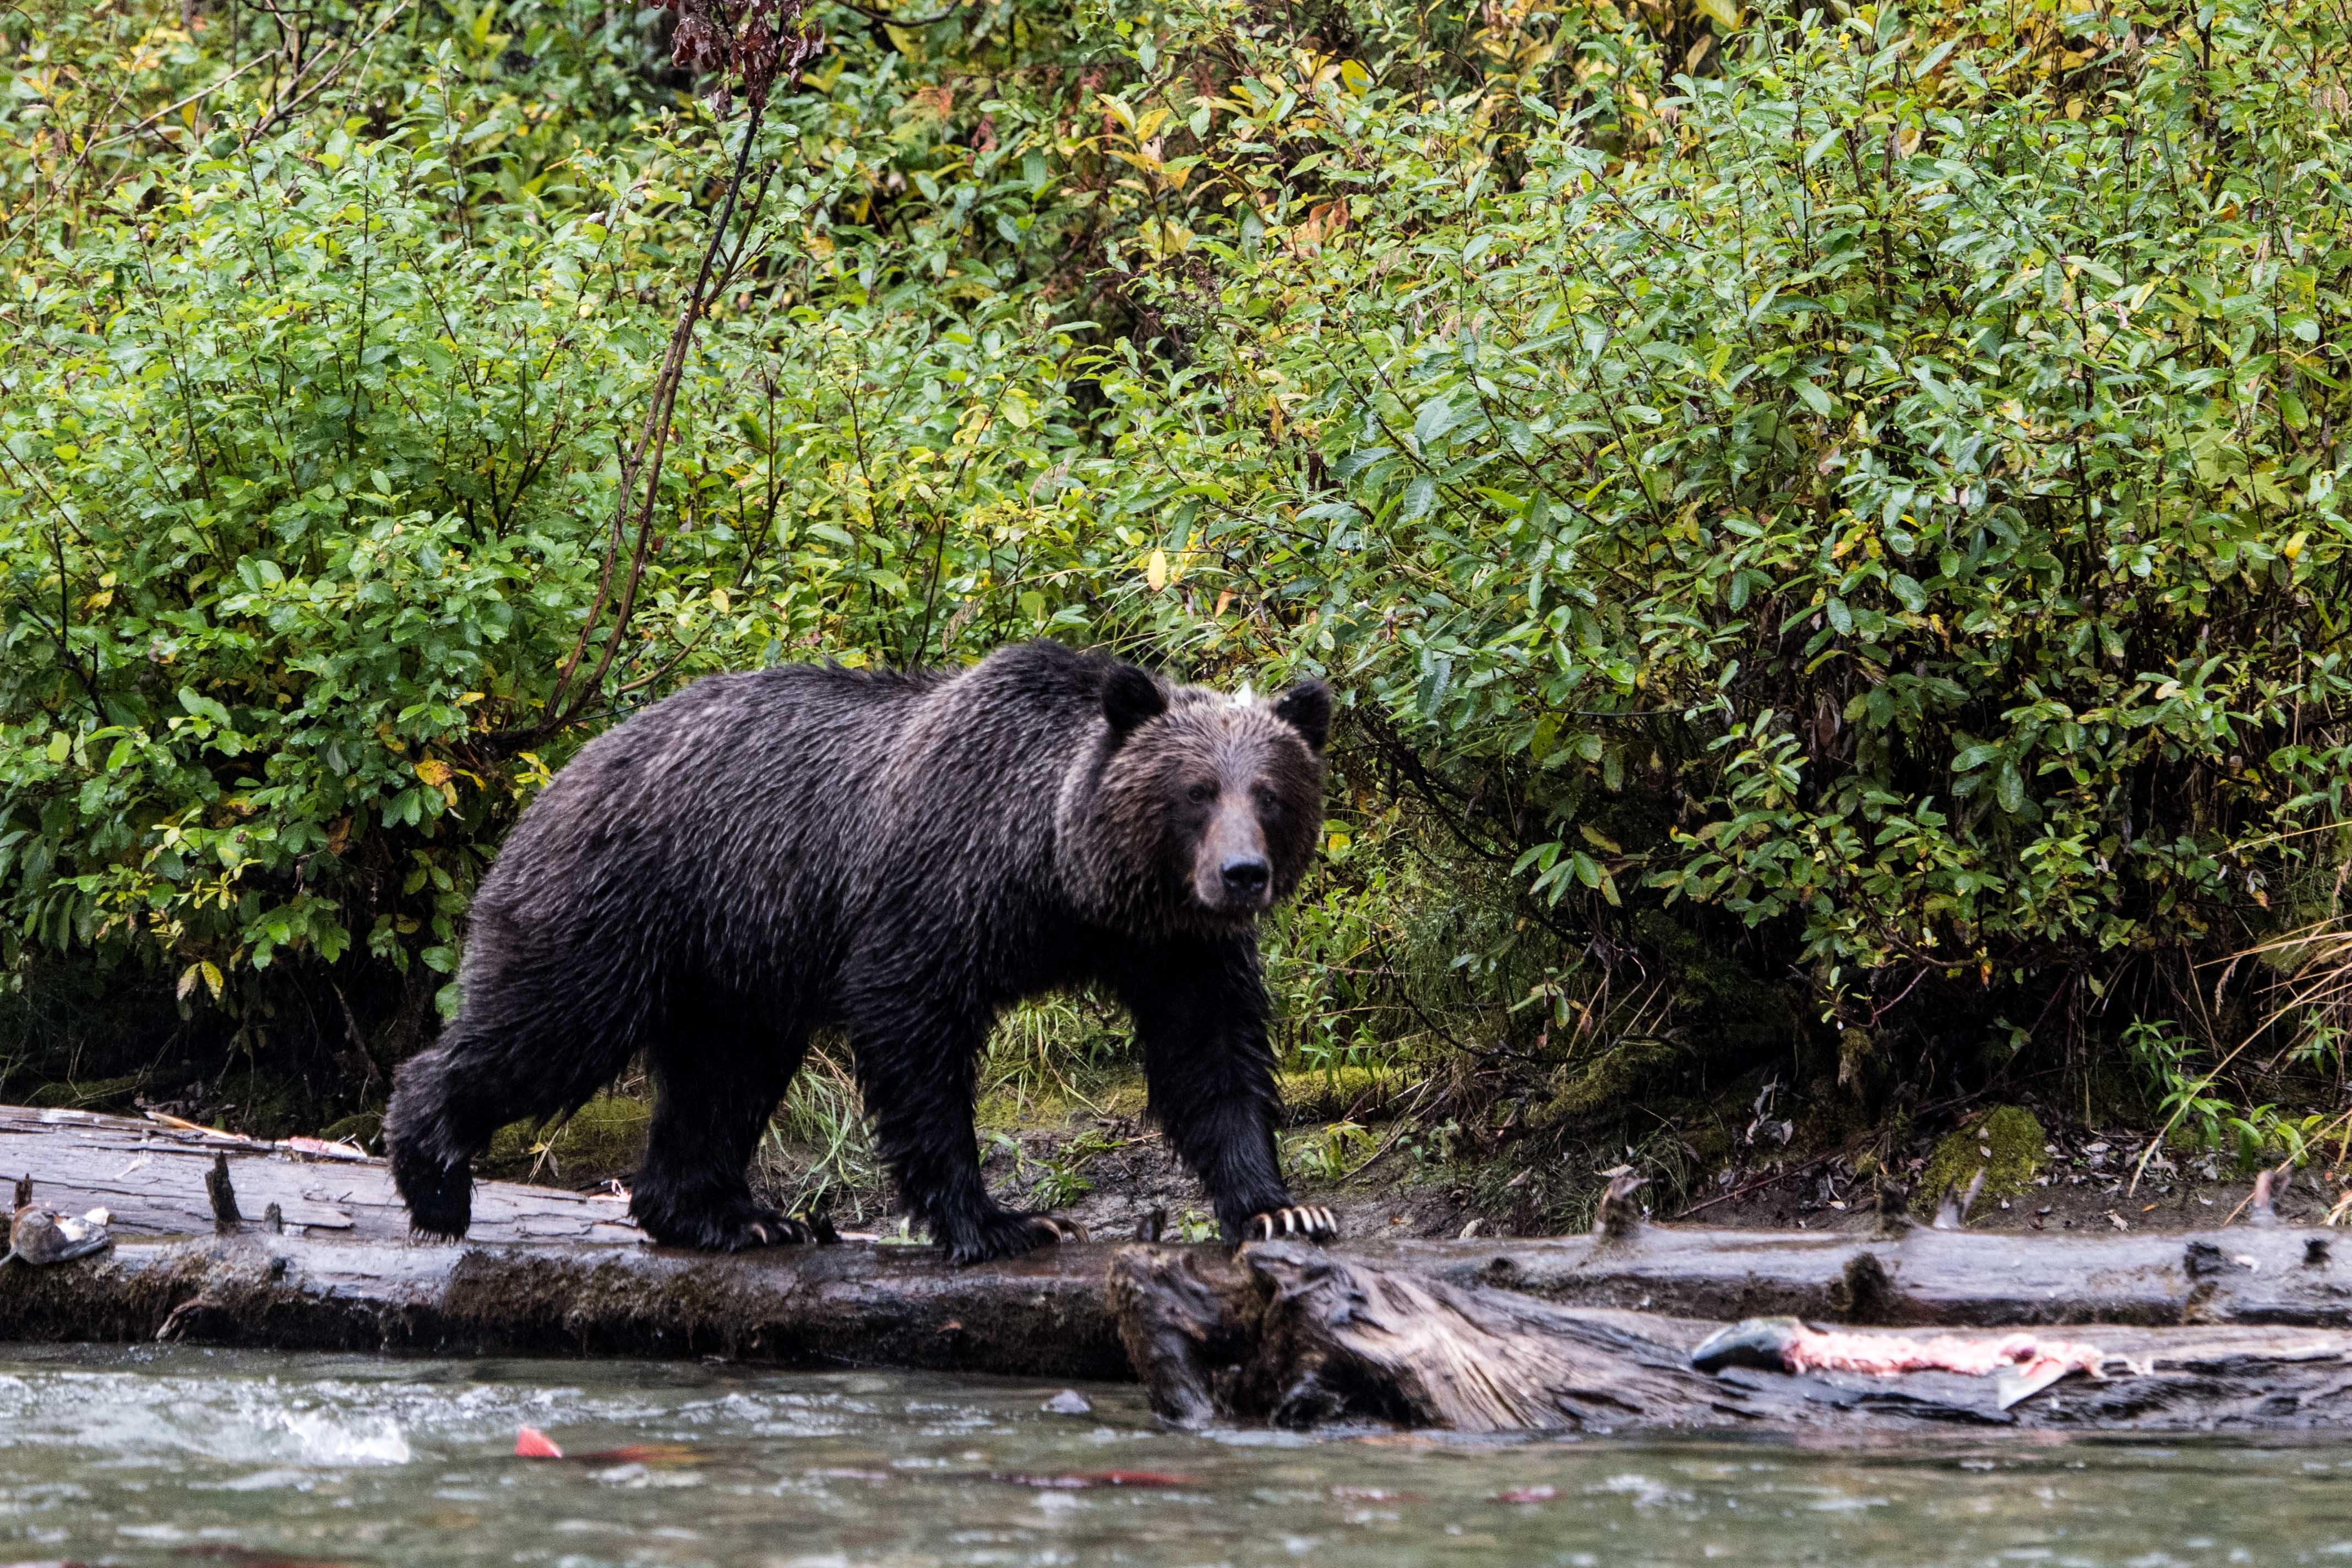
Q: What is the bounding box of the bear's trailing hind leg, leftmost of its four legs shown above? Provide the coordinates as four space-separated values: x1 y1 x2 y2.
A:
383 1020 628 1241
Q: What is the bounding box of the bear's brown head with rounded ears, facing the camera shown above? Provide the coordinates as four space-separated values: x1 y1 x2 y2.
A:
1072 663 1331 933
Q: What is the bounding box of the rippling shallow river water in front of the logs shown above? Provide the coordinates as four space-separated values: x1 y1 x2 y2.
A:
0 1347 2352 1568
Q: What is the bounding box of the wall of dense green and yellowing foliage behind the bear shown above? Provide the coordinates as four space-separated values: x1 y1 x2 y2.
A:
0 0 2352 1204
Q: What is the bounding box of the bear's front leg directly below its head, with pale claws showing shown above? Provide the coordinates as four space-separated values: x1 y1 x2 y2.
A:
1113 935 1338 1241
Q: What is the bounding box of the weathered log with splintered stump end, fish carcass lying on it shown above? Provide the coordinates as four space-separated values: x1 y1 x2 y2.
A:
1110 1241 2352 1431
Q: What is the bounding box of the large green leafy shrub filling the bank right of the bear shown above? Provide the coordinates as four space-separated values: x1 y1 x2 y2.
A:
1091 5 2352 1022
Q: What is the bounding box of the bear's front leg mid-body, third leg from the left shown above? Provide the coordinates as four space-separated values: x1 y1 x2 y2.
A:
849 992 1087 1262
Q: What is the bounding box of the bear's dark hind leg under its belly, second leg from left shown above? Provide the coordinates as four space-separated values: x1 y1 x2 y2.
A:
628 1018 816 1253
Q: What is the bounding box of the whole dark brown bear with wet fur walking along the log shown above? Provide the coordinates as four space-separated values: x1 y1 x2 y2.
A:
386 642 1331 1260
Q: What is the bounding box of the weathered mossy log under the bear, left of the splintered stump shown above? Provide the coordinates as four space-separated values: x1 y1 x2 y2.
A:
0 1107 1129 1378
